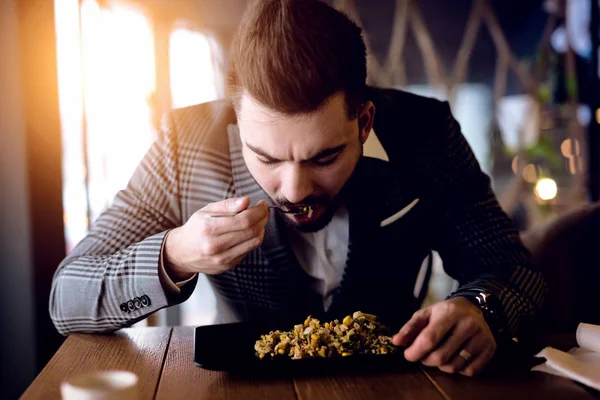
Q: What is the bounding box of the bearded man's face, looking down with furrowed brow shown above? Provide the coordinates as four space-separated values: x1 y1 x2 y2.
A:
238 93 375 231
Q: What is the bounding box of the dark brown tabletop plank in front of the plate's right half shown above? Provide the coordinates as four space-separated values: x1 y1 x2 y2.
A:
294 367 444 400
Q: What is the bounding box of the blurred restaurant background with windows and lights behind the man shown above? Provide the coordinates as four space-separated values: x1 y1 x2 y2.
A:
0 0 600 398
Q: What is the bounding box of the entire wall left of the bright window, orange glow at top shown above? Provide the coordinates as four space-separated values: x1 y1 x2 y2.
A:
0 0 65 398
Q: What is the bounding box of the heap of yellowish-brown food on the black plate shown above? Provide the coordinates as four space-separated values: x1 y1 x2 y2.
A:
254 311 396 360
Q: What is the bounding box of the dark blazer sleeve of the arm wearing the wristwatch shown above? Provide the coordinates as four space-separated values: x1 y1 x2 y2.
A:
431 103 545 335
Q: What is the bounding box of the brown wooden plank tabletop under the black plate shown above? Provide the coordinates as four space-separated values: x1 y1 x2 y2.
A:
22 327 597 400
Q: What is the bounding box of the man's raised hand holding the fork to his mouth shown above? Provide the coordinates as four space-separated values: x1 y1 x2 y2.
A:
163 197 269 281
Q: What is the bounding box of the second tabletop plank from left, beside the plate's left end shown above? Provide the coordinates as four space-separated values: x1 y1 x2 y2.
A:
156 327 296 400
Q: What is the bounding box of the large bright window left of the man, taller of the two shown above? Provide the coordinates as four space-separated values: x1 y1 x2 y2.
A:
56 0 156 251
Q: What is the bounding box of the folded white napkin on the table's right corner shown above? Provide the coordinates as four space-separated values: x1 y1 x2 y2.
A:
531 323 600 390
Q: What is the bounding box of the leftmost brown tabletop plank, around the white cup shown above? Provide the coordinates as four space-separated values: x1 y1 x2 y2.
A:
22 327 171 399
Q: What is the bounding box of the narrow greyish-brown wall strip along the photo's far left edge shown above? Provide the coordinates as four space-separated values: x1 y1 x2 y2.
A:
0 0 36 399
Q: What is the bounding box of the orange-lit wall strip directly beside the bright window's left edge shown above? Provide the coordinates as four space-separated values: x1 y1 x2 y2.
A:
13 0 66 376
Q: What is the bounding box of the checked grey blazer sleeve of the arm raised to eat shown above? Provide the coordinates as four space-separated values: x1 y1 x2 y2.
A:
49 114 195 335
